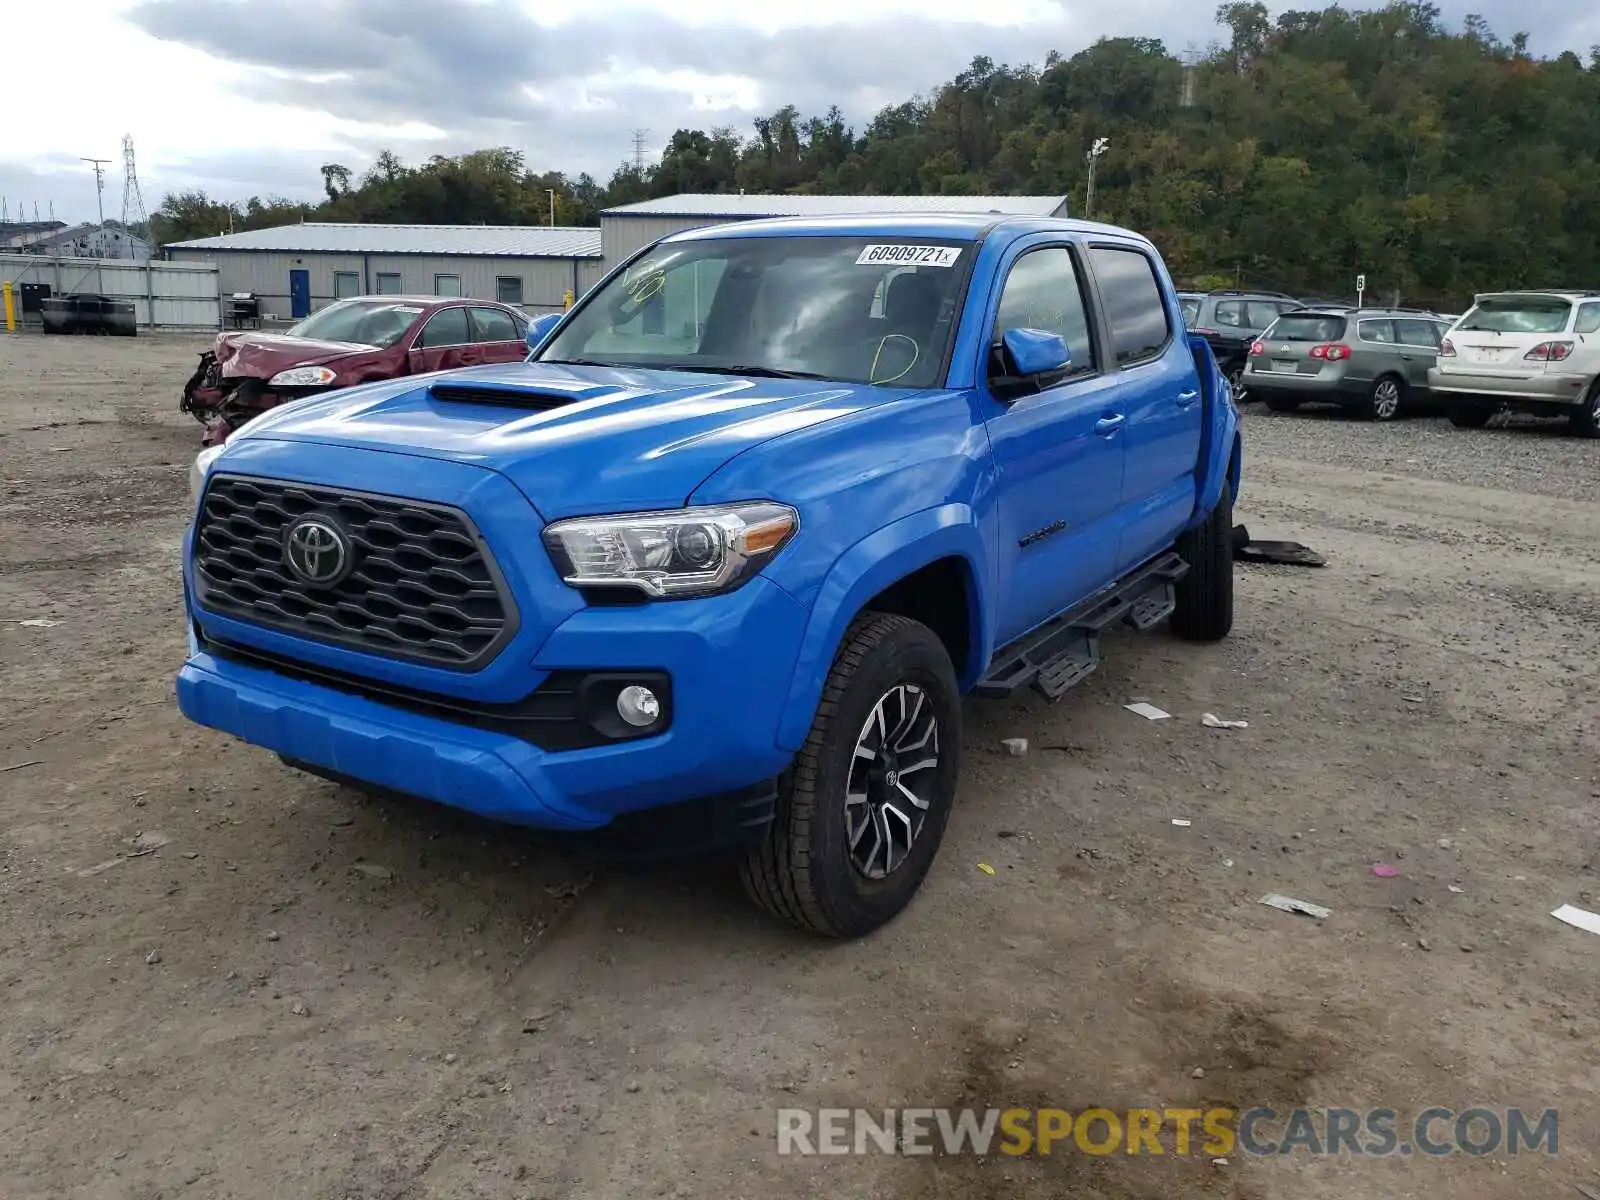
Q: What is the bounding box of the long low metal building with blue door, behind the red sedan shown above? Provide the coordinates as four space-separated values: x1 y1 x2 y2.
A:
165 221 602 320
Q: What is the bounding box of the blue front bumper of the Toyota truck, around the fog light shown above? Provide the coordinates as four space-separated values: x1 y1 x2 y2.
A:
178 489 808 830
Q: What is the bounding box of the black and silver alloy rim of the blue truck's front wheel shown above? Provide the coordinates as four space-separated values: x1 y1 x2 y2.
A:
845 683 939 880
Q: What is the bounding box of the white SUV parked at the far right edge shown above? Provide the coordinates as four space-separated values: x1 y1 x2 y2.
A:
1427 291 1600 437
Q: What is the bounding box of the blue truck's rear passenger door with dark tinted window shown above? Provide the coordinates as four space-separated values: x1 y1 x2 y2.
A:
1090 245 1205 573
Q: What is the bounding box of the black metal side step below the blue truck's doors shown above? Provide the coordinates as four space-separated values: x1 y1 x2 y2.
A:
974 550 1189 699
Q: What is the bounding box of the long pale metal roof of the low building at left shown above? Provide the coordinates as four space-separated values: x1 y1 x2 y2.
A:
168 221 600 258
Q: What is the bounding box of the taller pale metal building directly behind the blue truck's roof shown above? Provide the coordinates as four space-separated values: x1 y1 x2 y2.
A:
600 192 1067 269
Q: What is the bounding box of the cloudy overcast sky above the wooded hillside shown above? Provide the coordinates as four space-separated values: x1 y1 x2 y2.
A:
0 0 1600 221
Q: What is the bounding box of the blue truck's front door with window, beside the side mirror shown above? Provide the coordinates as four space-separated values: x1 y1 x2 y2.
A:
981 240 1128 643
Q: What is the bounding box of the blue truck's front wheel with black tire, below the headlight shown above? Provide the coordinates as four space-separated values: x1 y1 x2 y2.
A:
739 613 962 938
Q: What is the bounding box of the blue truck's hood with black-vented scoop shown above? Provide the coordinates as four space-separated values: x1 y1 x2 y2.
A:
240 363 906 520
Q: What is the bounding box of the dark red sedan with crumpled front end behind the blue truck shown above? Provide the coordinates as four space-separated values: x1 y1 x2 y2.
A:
179 296 528 446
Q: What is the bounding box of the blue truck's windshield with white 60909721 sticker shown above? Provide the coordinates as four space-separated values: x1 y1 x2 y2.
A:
539 237 973 387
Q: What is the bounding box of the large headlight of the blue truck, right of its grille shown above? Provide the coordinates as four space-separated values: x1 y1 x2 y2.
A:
544 501 800 598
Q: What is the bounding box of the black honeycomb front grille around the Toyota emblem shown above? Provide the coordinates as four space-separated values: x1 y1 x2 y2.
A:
195 475 517 670
